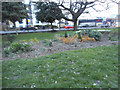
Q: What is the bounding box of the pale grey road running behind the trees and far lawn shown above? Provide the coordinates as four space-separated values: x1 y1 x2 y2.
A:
0 27 114 35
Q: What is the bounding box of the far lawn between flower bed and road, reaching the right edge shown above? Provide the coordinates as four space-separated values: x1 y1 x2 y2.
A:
0 28 119 42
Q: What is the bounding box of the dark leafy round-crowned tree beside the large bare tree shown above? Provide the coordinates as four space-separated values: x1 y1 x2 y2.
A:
36 2 64 30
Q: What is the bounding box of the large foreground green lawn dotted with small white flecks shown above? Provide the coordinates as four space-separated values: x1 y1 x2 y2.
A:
2 45 118 88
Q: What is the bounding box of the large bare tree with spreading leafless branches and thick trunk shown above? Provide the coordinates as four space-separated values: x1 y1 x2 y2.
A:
58 0 117 30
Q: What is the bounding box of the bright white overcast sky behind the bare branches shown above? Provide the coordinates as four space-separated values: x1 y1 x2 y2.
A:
25 0 119 19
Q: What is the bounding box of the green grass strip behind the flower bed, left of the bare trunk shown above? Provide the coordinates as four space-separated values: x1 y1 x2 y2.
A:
0 31 75 47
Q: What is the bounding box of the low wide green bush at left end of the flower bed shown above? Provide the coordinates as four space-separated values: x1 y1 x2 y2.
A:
3 43 32 56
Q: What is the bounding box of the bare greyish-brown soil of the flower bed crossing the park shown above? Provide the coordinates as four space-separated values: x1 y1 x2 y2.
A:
3 35 118 60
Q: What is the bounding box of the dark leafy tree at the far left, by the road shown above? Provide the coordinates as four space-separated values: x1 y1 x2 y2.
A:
2 2 28 33
